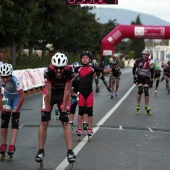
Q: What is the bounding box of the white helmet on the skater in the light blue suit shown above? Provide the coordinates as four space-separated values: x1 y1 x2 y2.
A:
0 63 13 76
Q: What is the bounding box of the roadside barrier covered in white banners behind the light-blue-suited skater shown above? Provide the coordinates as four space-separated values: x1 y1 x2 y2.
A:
13 68 45 95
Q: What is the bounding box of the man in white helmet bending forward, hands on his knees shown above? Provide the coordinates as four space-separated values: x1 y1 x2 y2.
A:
35 52 76 166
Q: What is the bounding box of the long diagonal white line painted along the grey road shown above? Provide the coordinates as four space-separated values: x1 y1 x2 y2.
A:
55 85 136 170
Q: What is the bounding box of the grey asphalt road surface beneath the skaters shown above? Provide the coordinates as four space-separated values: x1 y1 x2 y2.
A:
0 68 170 170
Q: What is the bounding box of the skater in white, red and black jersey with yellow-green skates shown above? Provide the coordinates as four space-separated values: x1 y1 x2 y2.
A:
132 49 154 115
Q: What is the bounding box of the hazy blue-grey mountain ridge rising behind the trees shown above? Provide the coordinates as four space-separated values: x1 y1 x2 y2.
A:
91 7 170 26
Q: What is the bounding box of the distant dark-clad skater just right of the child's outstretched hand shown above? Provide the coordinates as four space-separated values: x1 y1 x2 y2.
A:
110 60 122 99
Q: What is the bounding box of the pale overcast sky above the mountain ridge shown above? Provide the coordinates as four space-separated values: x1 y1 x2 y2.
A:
82 0 170 22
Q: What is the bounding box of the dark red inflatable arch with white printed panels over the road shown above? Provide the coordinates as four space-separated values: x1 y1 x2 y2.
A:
101 25 170 59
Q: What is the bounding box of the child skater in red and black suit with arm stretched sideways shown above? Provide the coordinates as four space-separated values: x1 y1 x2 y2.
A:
75 51 111 141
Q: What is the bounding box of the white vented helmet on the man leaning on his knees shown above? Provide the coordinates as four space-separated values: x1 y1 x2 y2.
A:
51 52 68 67
